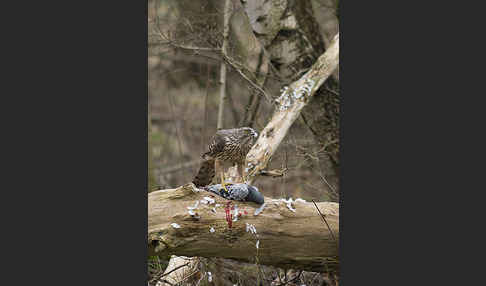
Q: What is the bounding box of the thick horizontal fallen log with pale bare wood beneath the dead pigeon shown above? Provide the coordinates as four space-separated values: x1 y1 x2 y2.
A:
148 184 339 272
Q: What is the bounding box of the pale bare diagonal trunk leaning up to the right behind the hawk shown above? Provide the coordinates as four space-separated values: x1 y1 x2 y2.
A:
244 34 339 181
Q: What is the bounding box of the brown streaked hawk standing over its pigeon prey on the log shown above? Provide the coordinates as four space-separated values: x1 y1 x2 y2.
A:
193 127 258 189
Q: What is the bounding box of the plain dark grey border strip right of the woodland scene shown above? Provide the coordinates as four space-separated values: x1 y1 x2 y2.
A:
339 1 478 285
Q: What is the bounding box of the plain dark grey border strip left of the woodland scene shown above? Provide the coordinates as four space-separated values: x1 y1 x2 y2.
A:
1 1 147 285
